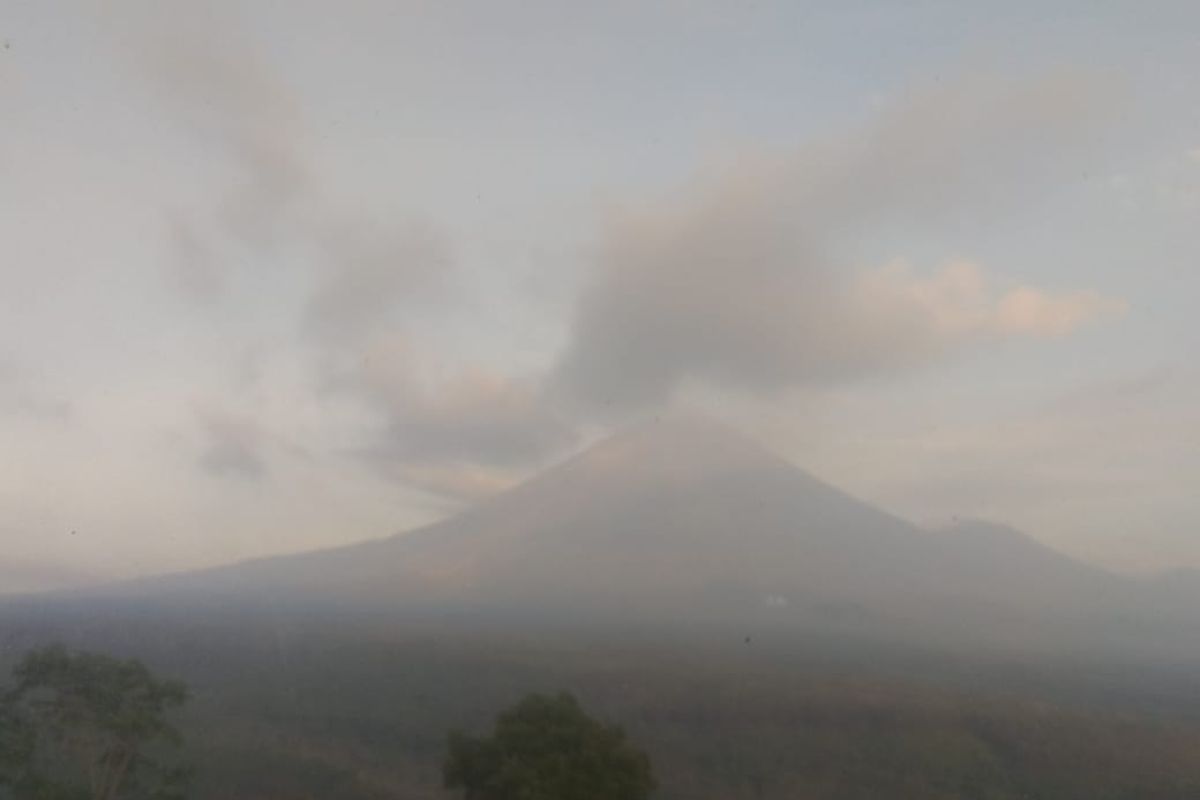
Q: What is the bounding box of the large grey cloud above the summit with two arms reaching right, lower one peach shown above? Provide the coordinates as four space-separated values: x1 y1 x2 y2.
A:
552 70 1121 410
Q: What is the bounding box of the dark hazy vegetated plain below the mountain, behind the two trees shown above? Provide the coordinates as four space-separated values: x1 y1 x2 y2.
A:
8 609 1200 800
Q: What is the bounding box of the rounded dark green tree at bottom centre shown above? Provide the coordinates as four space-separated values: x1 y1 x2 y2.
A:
443 693 654 800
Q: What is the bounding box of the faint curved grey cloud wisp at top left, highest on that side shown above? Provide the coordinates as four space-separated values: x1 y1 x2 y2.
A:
127 13 313 305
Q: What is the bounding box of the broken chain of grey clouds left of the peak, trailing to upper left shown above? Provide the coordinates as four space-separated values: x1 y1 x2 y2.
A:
136 12 506 497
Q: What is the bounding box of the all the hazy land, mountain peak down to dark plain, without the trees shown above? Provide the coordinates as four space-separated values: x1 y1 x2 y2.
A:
7 420 1200 800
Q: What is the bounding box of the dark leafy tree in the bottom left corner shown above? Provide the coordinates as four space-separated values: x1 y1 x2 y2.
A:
0 645 187 800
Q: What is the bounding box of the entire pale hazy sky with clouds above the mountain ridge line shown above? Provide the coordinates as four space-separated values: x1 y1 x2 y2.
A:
0 0 1200 590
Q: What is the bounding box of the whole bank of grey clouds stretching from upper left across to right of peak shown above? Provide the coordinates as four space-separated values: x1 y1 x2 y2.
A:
126 18 1123 498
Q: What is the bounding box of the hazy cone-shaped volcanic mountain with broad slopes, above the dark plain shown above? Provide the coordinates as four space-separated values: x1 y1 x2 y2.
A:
56 417 1171 652
